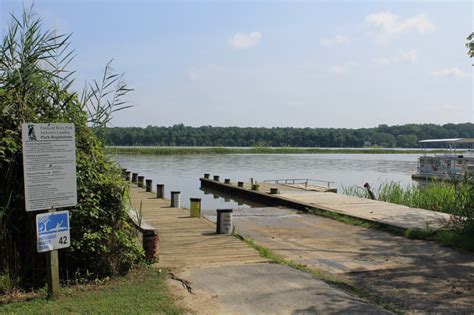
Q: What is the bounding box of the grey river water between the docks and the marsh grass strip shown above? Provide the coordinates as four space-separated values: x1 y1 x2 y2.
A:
112 154 419 209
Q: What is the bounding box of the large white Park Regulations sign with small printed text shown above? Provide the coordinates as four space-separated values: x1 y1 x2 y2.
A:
22 123 77 211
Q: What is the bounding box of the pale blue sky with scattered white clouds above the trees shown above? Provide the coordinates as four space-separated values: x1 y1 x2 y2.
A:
0 0 474 128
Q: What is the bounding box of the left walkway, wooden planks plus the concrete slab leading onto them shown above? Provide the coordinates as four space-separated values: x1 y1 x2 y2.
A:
130 186 388 314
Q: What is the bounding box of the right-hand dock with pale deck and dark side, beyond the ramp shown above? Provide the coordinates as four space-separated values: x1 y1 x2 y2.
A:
200 178 450 230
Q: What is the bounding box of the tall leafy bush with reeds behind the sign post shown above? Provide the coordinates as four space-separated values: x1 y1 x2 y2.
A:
0 11 143 293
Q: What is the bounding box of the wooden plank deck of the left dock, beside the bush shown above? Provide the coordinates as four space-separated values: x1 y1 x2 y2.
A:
130 185 267 268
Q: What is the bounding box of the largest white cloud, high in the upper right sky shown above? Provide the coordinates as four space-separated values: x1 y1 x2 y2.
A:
364 11 437 39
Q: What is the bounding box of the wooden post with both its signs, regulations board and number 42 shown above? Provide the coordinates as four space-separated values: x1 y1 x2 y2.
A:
22 123 77 298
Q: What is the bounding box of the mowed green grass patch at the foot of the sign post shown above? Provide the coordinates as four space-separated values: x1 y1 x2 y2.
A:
0 267 186 314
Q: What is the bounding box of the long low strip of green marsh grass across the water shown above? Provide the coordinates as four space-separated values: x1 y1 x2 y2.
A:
106 146 452 155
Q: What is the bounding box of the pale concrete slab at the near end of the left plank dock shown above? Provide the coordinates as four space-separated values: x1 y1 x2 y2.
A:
170 263 389 314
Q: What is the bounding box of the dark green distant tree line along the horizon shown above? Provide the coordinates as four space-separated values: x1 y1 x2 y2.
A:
105 123 474 148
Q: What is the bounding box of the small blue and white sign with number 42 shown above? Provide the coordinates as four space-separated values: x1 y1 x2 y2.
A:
36 210 70 253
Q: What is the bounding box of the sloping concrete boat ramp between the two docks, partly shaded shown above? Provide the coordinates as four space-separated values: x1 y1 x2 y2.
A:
204 207 474 313
